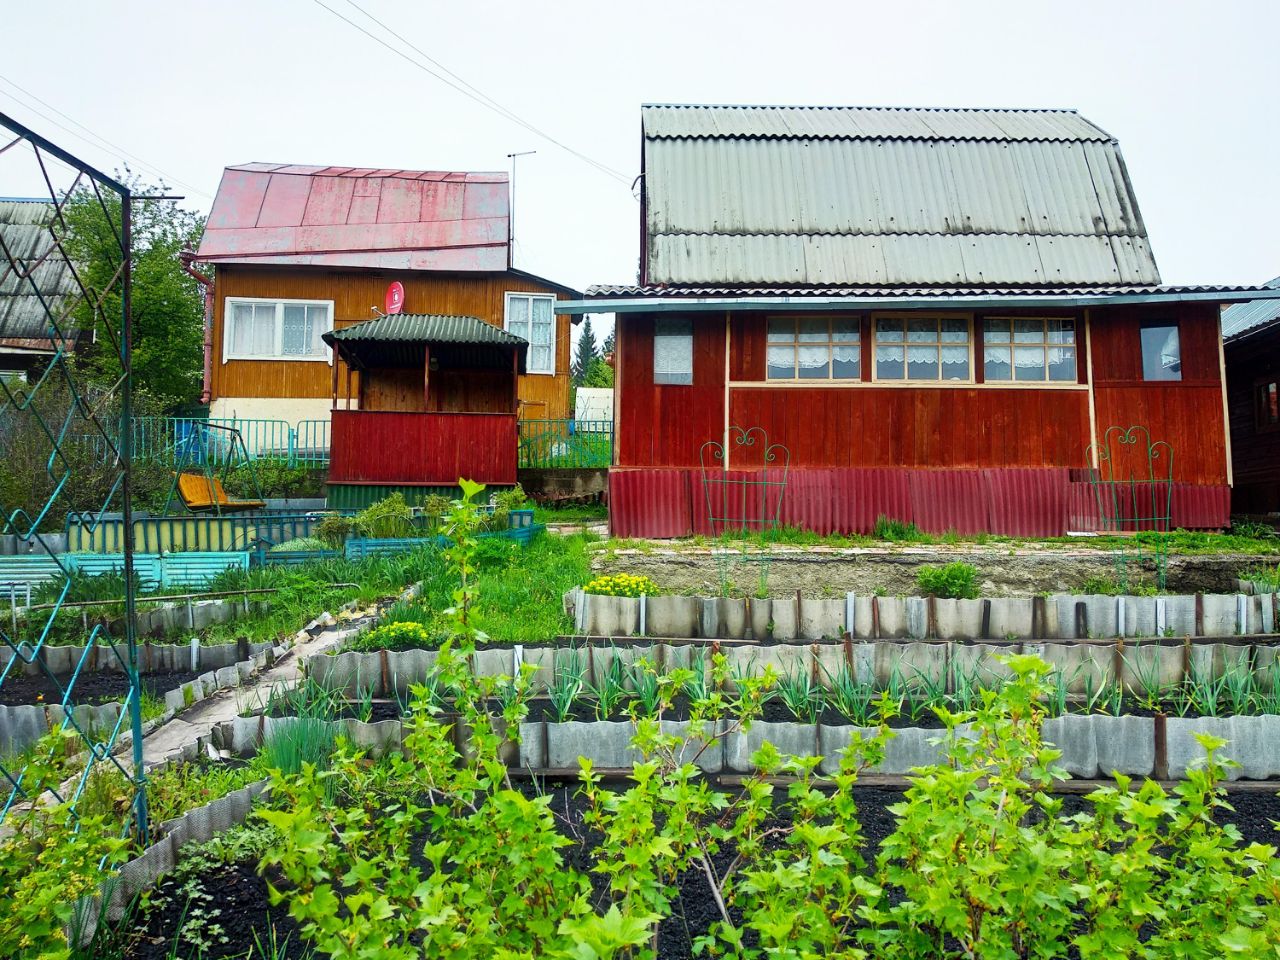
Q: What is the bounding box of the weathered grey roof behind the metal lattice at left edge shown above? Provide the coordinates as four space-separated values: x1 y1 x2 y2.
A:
0 197 79 353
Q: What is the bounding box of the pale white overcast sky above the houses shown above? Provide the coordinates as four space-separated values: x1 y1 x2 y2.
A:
0 0 1280 330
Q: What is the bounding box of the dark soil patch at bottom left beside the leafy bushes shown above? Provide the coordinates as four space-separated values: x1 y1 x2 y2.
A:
124 863 307 960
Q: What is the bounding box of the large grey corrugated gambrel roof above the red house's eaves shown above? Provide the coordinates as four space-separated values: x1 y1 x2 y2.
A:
641 105 1160 288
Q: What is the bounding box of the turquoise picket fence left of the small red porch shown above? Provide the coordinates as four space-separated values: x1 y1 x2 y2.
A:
81 417 329 467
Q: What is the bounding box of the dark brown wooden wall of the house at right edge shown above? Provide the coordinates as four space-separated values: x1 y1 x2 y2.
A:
1225 329 1280 513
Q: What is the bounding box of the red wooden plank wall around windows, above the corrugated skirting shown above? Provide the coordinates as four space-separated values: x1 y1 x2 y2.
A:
617 305 1226 485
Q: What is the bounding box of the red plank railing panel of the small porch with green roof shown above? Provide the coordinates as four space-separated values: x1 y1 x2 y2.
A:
329 410 518 486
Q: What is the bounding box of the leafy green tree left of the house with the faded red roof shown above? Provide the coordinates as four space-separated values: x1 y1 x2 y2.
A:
63 170 205 407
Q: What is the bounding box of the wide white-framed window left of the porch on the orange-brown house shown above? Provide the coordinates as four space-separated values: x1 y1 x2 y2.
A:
223 297 333 364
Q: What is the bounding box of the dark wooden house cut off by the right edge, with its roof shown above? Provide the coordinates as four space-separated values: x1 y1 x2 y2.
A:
1222 276 1280 515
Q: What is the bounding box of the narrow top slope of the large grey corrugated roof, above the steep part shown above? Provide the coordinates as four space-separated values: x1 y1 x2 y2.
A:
641 104 1111 142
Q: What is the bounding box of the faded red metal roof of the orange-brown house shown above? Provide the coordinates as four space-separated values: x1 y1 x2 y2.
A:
196 164 509 273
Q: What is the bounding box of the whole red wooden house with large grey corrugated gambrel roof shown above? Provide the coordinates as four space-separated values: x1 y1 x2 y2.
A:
558 105 1266 536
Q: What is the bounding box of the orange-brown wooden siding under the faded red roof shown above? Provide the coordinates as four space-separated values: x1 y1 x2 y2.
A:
210 266 572 420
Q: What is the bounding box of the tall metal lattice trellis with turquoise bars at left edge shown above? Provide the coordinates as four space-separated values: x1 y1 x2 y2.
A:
0 108 147 838
